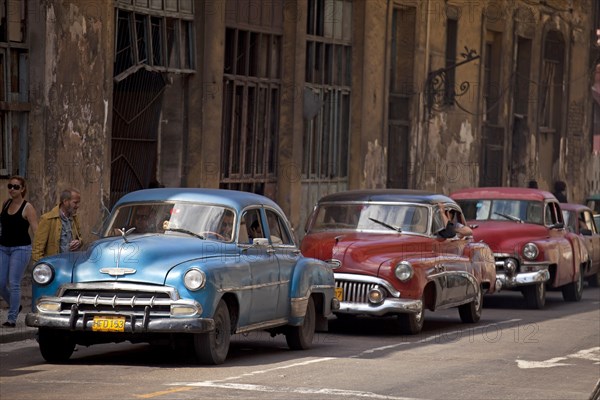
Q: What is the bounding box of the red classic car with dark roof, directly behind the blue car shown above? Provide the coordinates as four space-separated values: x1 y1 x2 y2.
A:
301 190 497 334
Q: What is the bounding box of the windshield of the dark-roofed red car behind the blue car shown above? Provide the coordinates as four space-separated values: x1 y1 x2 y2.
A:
310 203 429 234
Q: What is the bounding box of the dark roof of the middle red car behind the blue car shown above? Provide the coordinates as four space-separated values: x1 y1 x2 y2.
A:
319 189 454 204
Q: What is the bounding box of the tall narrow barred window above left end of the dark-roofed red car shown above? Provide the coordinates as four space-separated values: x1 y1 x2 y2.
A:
302 0 352 180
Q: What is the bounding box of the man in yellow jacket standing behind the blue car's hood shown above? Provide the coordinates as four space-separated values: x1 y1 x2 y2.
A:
31 189 83 262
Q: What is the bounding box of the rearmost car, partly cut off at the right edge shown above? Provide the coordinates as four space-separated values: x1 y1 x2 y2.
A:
560 203 600 287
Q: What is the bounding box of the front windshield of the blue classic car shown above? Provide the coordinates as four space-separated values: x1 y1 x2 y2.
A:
104 202 235 241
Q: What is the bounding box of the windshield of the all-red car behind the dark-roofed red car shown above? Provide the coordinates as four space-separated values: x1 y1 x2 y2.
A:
457 199 544 225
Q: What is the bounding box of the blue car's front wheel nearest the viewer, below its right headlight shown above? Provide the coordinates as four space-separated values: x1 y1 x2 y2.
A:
194 300 231 365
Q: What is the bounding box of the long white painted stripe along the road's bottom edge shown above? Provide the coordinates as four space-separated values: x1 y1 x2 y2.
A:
186 381 419 400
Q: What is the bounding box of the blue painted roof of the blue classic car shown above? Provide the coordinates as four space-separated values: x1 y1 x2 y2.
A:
115 188 283 214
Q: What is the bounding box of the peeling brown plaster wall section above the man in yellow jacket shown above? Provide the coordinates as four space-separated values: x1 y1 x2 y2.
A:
29 0 114 242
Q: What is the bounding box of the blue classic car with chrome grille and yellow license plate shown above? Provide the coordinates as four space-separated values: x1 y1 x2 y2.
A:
26 189 339 364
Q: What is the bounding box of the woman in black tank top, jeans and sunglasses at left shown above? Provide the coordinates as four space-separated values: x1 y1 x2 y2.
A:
0 176 37 328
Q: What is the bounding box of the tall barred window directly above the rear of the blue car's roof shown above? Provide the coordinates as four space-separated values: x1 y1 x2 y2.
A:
220 0 283 197
